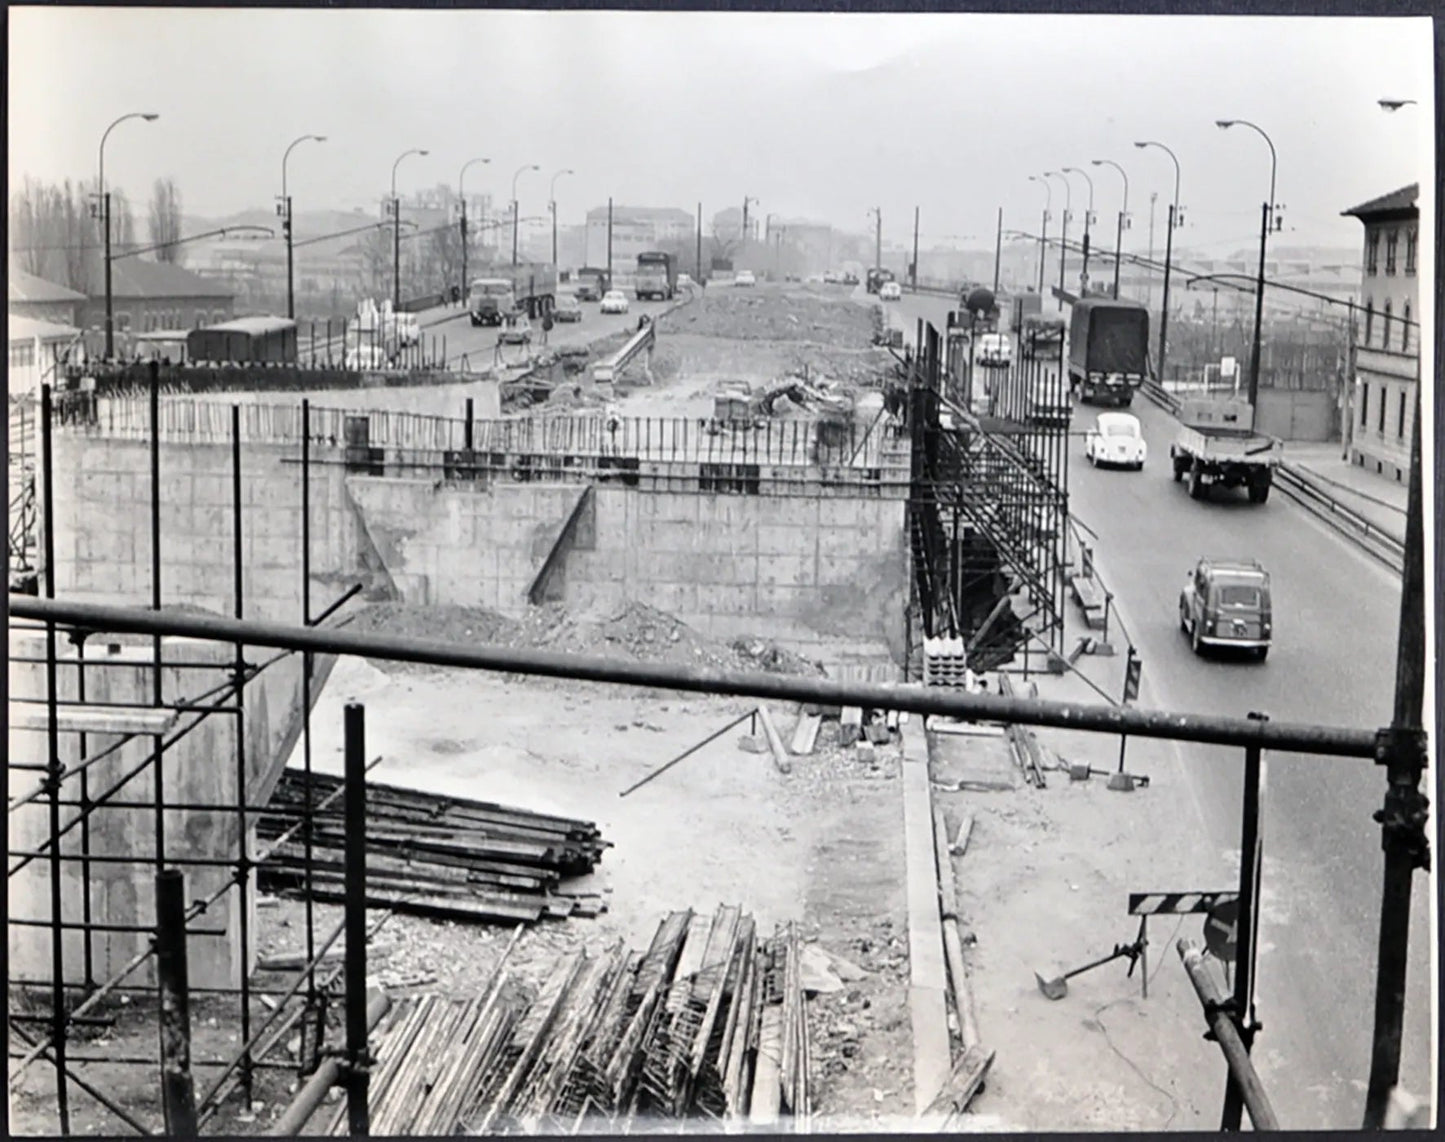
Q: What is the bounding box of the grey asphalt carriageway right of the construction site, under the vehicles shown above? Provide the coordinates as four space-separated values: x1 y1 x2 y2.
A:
893 296 1433 1129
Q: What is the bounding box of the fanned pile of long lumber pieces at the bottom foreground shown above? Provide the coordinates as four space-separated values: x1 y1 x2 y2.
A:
319 905 809 1135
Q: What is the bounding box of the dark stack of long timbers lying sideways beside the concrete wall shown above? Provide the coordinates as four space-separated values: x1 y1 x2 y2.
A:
257 769 610 924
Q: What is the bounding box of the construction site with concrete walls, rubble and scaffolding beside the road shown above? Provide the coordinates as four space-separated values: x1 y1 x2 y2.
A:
7 283 1428 1136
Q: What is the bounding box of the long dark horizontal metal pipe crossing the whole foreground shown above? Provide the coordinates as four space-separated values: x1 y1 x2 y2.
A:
10 597 1376 760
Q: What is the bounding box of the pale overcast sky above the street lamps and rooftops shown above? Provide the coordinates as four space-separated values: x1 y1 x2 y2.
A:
9 7 1433 253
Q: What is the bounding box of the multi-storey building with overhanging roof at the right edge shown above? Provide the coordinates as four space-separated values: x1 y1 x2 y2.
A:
1342 182 1420 480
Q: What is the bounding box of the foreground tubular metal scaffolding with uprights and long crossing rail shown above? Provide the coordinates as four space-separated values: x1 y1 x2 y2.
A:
2 368 1429 1135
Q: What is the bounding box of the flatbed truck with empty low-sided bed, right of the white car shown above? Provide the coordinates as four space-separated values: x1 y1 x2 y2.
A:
1169 398 1285 503
